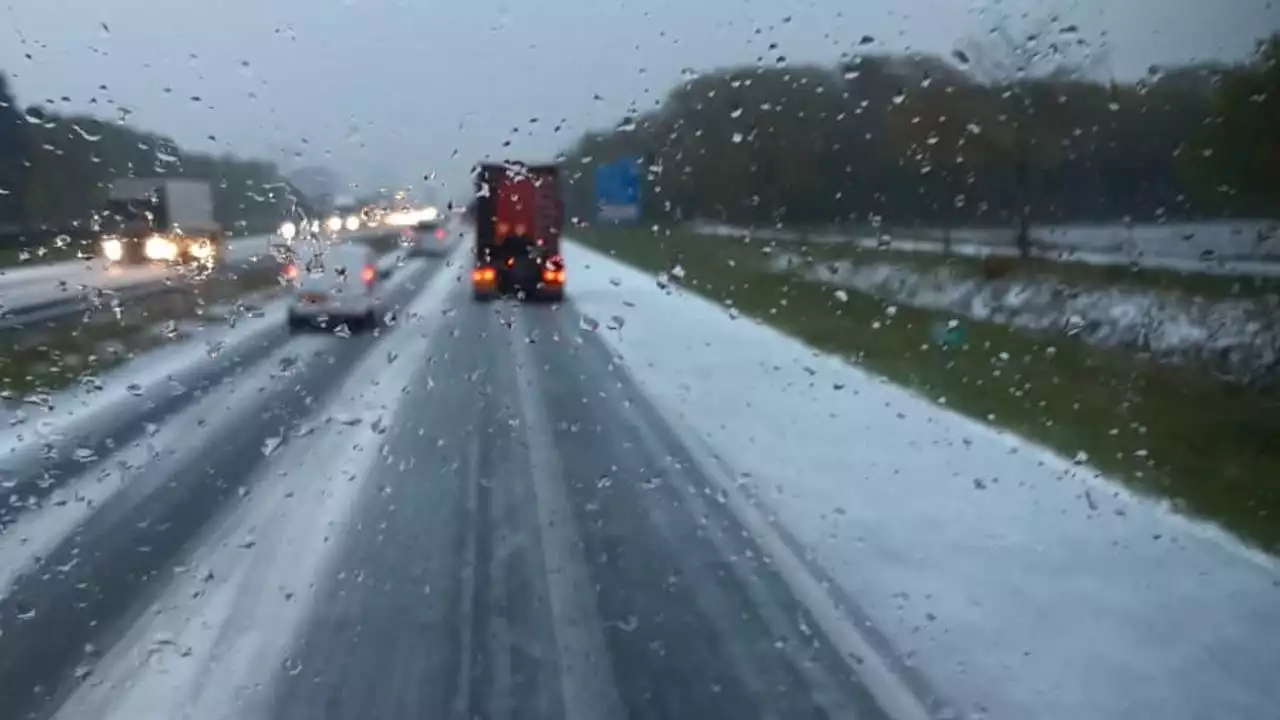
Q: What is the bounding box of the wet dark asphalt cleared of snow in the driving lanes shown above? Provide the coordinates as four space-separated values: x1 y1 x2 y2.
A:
0 254 886 720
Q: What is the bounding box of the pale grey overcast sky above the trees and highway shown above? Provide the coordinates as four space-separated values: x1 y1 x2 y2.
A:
0 0 1280 196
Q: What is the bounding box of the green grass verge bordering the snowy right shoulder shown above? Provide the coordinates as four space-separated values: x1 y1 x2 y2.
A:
575 228 1280 552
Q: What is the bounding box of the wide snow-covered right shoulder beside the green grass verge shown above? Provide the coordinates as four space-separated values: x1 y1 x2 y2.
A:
566 239 1280 720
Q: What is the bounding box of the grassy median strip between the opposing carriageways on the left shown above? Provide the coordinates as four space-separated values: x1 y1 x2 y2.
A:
0 263 279 401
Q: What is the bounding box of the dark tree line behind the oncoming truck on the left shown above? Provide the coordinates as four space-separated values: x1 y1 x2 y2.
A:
0 73 307 241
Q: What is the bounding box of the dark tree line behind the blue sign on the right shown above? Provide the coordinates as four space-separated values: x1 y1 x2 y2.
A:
563 35 1280 236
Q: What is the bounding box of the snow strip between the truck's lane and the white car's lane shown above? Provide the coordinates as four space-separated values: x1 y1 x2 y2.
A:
56 248 458 720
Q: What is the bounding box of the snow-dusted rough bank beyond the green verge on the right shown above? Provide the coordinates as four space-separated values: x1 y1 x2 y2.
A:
772 249 1280 383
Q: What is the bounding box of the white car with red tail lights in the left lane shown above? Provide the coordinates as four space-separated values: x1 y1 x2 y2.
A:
284 242 390 332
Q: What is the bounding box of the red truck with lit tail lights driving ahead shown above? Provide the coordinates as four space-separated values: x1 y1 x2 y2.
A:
471 163 564 301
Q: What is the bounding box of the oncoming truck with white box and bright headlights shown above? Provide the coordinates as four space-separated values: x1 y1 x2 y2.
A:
101 178 223 264
